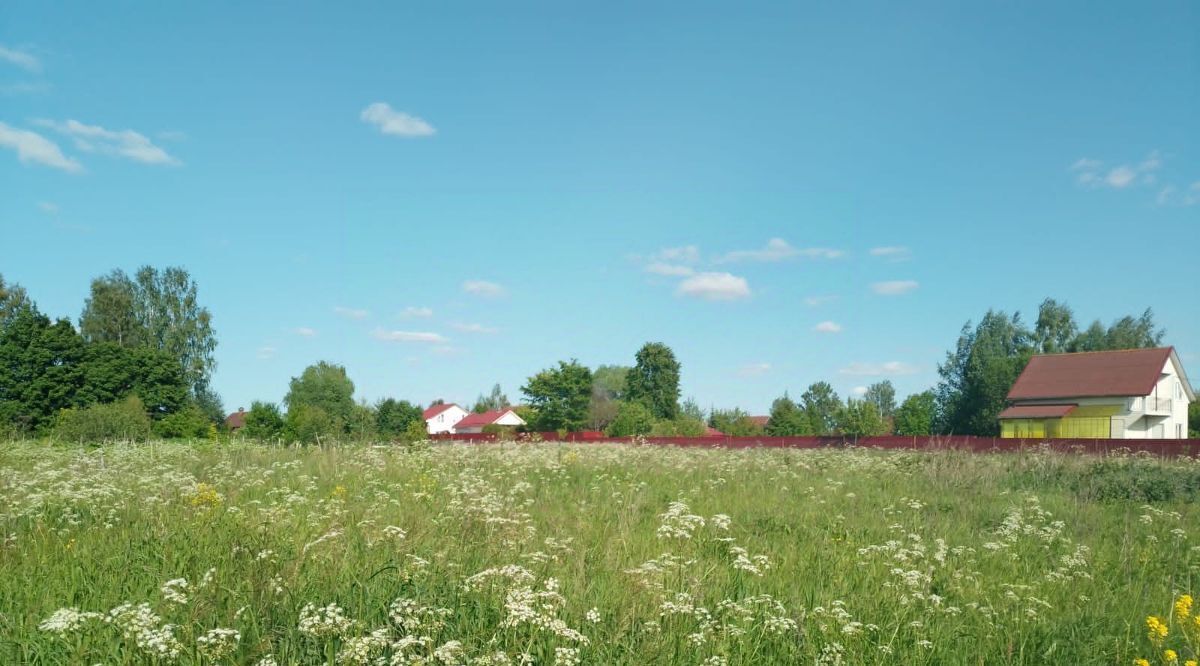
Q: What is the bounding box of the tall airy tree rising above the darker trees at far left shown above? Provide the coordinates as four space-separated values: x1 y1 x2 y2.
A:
79 266 217 397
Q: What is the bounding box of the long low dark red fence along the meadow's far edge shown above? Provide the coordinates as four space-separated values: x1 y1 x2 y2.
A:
432 432 1200 456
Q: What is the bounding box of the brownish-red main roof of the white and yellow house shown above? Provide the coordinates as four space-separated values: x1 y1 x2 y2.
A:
1008 347 1172 400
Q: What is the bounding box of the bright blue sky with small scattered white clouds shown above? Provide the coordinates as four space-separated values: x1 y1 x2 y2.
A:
0 1 1200 413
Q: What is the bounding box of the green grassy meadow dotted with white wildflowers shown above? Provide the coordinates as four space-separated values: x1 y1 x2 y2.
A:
0 443 1200 666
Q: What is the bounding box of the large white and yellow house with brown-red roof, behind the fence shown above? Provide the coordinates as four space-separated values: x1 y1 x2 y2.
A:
1000 347 1196 439
